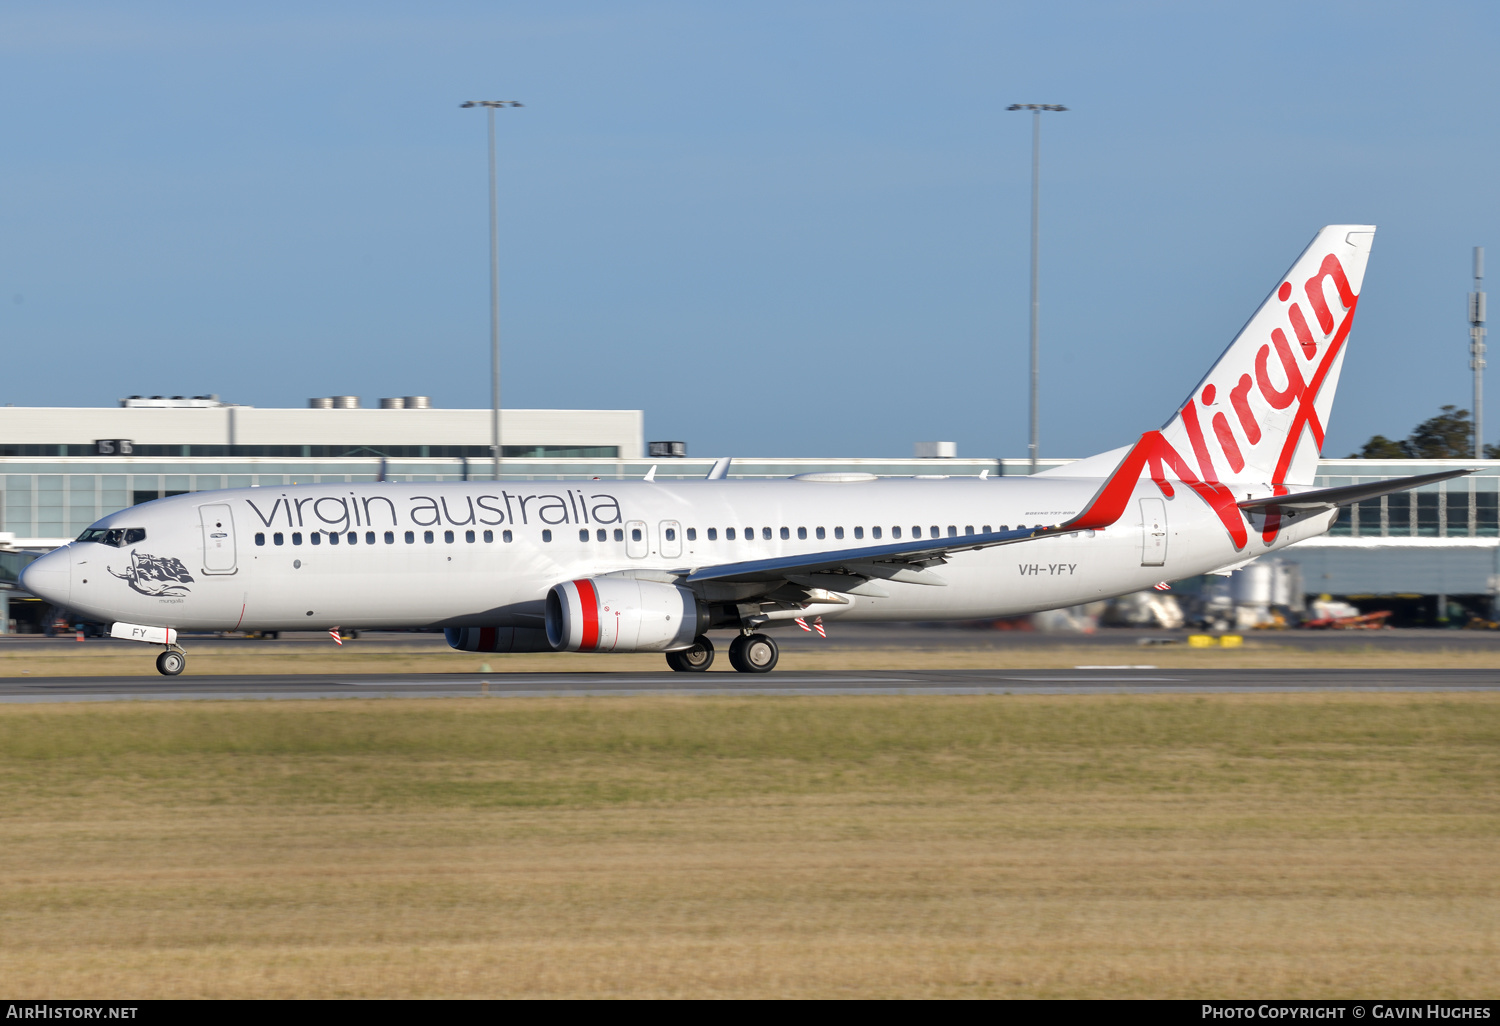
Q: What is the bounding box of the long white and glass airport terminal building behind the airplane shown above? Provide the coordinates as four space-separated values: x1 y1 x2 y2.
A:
0 396 1500 632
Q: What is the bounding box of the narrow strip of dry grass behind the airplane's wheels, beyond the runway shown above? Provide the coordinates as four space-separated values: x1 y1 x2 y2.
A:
0 636 1500 678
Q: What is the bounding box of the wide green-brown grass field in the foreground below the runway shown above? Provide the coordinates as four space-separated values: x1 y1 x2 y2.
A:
0 695 1500 998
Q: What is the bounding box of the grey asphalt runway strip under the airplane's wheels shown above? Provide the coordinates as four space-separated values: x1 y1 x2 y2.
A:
0 666 1500 702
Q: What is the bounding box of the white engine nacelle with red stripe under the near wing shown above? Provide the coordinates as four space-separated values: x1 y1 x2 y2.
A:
546 578 710 653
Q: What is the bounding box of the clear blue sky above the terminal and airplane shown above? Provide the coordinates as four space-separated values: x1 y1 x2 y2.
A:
0 0 1500 456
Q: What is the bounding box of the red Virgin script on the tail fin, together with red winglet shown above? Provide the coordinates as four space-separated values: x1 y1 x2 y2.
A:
1068 254 1359 549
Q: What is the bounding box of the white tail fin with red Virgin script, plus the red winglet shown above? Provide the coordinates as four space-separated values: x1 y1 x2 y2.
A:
1073 225 1374 549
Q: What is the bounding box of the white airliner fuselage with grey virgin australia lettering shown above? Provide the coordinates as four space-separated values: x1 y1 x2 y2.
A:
27 476 1332 630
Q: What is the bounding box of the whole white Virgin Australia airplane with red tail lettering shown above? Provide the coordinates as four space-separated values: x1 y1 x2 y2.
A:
21 225 1470 675
